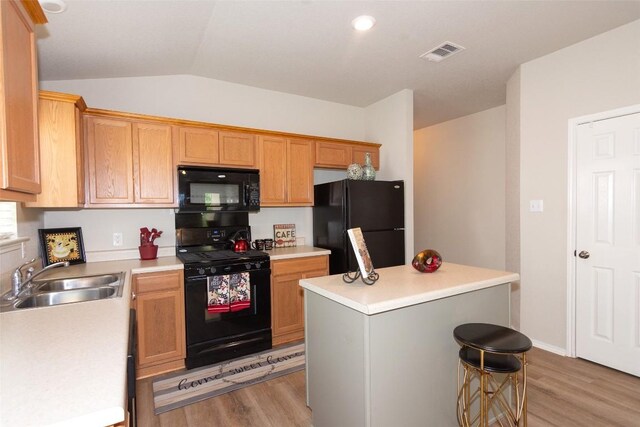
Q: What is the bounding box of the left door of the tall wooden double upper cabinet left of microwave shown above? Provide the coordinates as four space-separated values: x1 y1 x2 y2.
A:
85 117 134 204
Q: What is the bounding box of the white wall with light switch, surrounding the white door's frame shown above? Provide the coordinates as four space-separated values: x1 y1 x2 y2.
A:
507 20 640 351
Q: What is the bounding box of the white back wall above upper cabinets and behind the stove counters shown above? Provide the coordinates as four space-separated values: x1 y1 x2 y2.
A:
41 75 370 260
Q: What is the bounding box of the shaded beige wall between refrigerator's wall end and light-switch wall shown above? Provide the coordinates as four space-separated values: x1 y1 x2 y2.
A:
414 106 505 270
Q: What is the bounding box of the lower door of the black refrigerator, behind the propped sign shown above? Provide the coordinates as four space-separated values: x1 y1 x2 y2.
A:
348 230 404 274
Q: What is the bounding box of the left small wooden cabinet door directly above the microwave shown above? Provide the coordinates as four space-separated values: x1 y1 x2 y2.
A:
178 127 220 165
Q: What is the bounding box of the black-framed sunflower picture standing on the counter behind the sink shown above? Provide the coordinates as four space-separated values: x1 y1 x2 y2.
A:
38 227 86 265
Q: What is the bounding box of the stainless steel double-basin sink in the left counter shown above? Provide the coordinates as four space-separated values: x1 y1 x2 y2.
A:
0 272 125 312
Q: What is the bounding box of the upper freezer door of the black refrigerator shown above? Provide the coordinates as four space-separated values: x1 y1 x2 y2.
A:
346 181 404 231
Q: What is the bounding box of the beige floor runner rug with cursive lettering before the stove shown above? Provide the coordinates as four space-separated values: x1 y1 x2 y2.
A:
153 343 305 415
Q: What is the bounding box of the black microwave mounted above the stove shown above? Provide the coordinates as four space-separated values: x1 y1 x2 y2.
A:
178 166 260 212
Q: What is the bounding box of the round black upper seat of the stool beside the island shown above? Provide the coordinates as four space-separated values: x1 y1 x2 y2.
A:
453 323 532 353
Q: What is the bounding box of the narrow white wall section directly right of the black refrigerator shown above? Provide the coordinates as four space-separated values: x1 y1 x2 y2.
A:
365 89 415 263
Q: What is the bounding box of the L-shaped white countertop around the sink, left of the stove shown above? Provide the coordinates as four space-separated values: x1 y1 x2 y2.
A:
0 257 183 427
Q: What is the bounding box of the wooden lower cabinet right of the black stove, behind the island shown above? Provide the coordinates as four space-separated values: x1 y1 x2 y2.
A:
271 255 329 346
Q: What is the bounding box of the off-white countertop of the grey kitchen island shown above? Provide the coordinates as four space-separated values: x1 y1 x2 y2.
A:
300 262 520 315
